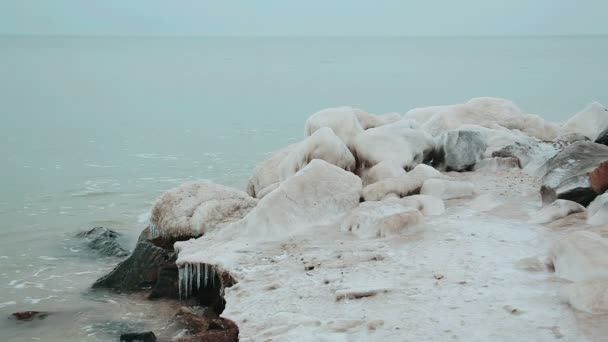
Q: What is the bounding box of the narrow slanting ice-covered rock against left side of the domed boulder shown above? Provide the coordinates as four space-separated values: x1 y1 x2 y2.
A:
247 144 298 198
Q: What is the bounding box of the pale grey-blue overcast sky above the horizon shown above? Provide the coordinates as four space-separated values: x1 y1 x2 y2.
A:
0 0 608 36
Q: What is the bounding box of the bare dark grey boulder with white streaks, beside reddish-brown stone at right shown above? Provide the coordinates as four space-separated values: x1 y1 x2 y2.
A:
539 141 608 205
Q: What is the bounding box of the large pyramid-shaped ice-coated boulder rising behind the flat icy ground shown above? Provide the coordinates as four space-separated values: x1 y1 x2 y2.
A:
237 159 362 239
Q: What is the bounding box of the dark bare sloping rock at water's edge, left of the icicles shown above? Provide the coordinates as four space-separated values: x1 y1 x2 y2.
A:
93 241 170 292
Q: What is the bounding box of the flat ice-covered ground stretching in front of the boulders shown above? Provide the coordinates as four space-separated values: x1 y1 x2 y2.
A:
173 169 608 341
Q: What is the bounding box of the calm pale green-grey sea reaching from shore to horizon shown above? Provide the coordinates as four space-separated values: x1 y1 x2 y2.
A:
0 36 608 342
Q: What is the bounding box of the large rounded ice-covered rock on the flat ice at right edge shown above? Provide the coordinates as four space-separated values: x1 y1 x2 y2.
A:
549 231 608 281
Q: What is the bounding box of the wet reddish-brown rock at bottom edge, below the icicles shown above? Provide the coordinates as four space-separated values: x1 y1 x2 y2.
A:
176 307 239 342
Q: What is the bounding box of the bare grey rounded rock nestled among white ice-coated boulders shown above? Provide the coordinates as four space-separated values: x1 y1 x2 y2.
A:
433 130 488 171
